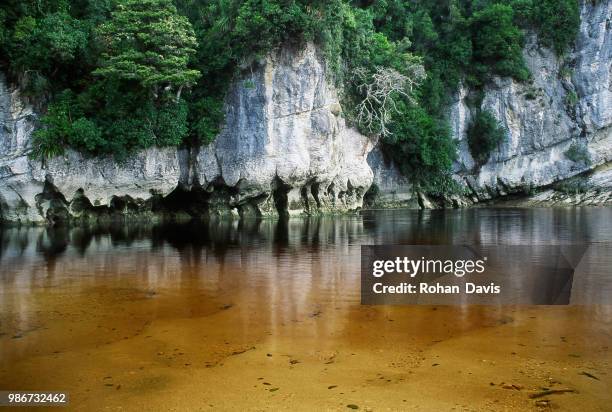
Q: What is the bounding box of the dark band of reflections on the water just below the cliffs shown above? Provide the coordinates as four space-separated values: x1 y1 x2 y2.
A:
0 209 612 262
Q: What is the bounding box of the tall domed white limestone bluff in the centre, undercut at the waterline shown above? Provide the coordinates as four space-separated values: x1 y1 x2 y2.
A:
193 44 373 219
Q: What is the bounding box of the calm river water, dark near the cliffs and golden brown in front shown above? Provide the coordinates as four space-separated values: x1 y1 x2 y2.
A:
0 208 612 411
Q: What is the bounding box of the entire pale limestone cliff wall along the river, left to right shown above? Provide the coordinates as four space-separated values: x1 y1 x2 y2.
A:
0 0 612 222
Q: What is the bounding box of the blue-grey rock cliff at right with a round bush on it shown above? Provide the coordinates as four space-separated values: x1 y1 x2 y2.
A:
450 1 612 200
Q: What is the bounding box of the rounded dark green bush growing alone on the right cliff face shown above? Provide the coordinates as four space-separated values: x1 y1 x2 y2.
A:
467 110 506 164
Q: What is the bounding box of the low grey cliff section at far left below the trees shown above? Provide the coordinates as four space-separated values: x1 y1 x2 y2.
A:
0 72 181 222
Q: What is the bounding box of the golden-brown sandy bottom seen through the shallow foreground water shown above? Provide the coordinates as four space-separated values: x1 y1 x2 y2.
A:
0 246 612 411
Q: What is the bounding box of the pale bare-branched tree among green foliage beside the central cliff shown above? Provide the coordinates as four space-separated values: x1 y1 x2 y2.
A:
353 62 426 137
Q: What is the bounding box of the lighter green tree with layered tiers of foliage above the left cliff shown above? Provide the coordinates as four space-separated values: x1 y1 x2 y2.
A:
94 0 200 102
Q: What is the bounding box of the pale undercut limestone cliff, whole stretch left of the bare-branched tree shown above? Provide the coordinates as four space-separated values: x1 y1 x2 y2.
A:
0 45 372 222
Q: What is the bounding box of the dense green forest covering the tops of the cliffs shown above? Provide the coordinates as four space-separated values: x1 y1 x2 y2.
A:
0 0 579 190
